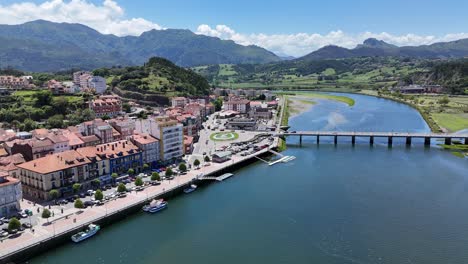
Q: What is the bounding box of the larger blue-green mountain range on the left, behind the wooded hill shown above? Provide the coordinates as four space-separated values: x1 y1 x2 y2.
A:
0 20 281 72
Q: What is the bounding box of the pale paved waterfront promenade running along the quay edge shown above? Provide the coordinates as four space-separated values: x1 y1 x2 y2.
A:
0 143 278 263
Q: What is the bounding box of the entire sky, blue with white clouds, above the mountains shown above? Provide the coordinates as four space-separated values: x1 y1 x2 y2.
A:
0 0 468 56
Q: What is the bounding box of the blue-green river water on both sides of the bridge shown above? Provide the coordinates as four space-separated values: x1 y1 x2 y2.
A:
30 95 468 264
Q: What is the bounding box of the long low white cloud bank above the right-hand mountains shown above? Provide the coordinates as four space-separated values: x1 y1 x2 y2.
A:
196 24 468 56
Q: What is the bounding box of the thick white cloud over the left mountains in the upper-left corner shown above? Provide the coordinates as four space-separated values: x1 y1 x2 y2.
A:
0 0 162 36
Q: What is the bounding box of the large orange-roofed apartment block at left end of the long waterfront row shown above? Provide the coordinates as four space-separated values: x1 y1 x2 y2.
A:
18 150 91 200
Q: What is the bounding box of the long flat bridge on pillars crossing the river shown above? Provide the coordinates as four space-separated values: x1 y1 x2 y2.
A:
273 131 468 146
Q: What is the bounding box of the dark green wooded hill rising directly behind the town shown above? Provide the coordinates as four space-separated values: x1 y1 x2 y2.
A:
101 57 210 103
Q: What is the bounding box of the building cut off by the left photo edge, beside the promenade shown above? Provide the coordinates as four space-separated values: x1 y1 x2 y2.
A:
0 171 23 218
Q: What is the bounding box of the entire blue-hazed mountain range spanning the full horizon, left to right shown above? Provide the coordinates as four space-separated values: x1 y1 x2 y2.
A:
0 20 468 72
